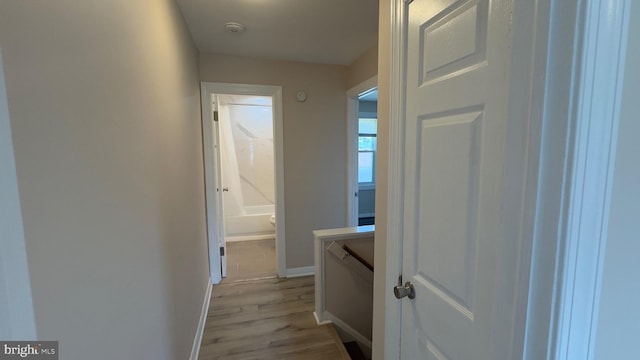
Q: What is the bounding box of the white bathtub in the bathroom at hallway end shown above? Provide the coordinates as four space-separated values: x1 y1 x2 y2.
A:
224 205 275 241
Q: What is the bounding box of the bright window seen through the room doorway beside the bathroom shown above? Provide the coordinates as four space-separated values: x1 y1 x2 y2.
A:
358 118 378 184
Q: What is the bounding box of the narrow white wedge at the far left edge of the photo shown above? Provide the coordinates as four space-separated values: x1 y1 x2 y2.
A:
0 47 36 340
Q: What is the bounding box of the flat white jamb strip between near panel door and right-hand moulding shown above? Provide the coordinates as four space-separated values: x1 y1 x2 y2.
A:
497 0 550 359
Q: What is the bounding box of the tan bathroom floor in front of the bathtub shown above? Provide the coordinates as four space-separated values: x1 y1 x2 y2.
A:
223 239 277 282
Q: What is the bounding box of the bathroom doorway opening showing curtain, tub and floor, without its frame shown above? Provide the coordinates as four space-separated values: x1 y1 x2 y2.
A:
217 94 277 281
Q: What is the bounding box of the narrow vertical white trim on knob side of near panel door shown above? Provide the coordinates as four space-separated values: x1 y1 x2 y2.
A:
382 0 407 360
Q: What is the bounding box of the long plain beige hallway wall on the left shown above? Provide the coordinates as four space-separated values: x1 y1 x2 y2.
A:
0 0 209 360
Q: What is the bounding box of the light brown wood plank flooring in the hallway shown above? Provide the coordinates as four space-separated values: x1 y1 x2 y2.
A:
199 276 350 360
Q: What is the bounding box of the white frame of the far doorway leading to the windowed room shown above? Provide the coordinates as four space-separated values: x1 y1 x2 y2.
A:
347 75 378 226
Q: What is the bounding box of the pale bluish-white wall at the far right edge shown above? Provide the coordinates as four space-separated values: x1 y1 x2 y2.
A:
595 1 640 360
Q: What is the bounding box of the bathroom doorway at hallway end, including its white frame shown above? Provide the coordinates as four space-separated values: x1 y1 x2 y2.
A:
202 83 285 283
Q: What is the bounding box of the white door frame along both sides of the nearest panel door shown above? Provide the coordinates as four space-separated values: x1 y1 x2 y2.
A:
384 0 629 360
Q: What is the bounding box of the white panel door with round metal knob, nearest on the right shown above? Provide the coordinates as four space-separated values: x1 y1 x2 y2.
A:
401 0 516 360
